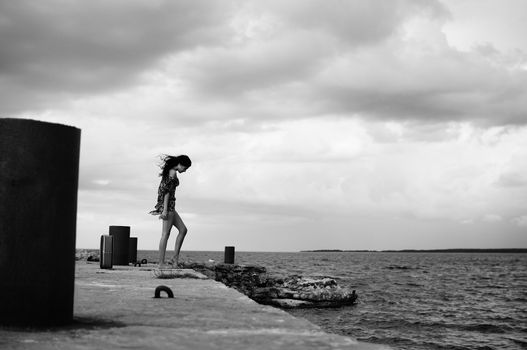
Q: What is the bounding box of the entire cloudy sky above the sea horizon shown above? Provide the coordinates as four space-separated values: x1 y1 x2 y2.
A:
0 0 527 251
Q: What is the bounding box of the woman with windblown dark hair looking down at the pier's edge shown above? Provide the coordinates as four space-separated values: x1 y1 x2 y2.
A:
149 155 192 268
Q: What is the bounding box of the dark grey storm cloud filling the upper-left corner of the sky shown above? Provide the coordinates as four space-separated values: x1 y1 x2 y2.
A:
0 0 235 111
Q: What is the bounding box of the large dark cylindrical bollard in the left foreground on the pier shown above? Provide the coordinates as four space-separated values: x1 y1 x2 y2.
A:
0 118 81 326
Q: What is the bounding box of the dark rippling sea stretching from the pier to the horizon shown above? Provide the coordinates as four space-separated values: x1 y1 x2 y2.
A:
118 251 527 350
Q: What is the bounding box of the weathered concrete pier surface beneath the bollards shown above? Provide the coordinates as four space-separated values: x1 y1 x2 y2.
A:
0 261 388 350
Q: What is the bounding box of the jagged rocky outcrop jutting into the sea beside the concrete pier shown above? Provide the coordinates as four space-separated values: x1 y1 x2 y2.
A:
181 262 357 308
